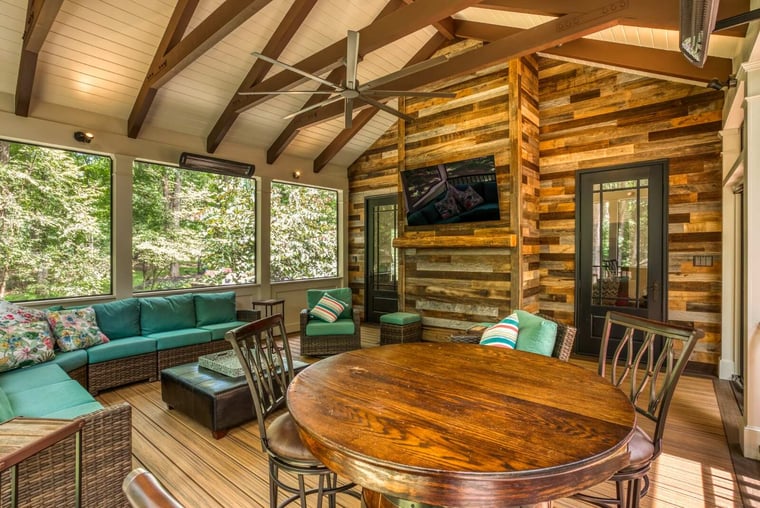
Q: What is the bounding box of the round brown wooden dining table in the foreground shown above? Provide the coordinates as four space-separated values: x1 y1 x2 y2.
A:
287 343 636 508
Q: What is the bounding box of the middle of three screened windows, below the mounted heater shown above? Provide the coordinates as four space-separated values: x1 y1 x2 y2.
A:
132 162 256 292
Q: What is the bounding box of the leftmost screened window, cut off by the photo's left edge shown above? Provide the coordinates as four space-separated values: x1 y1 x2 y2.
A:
0 140 111 301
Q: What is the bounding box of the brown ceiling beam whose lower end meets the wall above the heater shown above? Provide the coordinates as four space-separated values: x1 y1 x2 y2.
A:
206 0 317 153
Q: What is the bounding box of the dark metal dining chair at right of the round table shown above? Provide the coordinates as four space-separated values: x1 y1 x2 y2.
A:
574 311 704 508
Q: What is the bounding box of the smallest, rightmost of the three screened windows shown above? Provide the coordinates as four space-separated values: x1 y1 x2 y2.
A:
270 182 338 282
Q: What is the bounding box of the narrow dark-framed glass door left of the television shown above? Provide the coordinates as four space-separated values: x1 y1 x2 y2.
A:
365 194 398 323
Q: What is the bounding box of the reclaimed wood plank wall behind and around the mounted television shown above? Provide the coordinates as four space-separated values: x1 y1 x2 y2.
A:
348 55 516 340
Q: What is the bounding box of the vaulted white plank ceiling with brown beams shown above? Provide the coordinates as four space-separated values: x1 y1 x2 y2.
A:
0 0 749 170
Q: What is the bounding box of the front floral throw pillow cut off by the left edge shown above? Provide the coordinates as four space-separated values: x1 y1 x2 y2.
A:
0 320 55 372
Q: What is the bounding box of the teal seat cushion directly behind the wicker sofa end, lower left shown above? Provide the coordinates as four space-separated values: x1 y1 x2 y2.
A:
8 378 95 418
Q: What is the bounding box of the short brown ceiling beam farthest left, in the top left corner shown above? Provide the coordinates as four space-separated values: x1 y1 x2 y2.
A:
15 0 63 116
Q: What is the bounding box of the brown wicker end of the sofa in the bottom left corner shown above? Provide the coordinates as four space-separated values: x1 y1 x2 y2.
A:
0 403 132 508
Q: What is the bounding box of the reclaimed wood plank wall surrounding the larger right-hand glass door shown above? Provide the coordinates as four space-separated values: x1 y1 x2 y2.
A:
539 58 723 365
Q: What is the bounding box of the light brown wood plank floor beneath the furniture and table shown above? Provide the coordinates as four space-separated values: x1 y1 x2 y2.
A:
98 327 760 508
